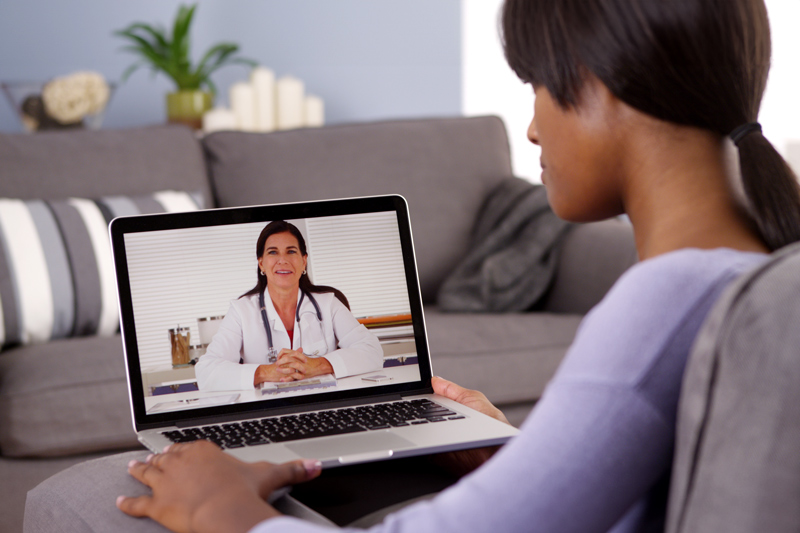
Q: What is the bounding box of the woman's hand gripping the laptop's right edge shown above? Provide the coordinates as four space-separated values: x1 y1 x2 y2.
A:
431 377 511 477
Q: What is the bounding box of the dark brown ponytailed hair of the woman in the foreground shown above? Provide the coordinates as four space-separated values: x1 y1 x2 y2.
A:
502 0 800 250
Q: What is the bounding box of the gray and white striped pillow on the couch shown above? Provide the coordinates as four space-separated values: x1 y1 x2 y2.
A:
0 191 203 346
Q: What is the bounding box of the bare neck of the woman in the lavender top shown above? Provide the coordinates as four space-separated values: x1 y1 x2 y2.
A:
623 119 768 259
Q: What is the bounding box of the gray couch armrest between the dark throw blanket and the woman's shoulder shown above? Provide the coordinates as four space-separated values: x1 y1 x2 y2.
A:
543 219 637 314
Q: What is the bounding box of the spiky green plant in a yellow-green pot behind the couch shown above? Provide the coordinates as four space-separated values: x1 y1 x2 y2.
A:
114 4 256 129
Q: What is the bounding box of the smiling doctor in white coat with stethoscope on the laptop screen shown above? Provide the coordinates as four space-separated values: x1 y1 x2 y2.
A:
195 220 383 390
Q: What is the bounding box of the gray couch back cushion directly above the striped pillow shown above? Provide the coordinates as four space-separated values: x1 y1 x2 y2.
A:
0 126 211 203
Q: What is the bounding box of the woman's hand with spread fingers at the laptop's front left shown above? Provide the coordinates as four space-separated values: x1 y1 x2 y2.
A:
117 441 321 532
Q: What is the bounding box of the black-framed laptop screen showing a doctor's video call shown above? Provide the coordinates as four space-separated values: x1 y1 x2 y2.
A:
111 196 430 429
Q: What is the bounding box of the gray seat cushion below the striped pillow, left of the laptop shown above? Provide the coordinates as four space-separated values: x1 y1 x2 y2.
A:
0 336 137 457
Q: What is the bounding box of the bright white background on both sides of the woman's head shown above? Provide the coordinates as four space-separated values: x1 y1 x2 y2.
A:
461 0 800 182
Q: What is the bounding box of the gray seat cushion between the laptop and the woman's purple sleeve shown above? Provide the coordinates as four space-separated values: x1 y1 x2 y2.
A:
425 306 583 404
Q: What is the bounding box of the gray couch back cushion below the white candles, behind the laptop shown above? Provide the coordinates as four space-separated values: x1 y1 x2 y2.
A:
203 117 511 301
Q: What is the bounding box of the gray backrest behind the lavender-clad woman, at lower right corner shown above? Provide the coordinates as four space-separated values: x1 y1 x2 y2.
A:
667 244 800 533
